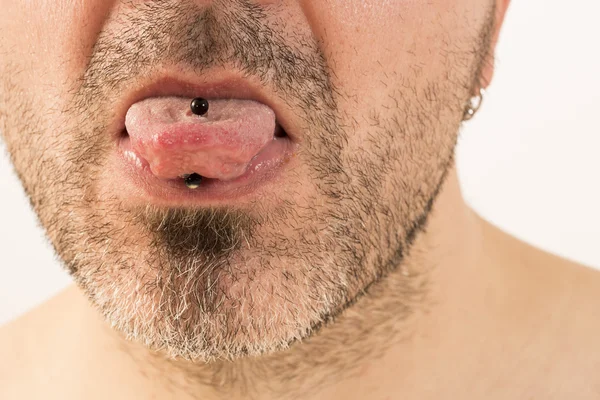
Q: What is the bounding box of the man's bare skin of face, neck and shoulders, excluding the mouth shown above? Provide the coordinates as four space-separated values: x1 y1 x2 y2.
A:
0 0 600 399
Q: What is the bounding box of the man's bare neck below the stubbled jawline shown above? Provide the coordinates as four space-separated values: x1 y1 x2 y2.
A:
59 166 506 400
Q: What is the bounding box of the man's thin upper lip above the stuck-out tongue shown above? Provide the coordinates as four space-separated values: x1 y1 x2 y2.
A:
111 69 298 141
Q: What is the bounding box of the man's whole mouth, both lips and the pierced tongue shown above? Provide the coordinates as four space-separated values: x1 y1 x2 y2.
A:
105 69 299 206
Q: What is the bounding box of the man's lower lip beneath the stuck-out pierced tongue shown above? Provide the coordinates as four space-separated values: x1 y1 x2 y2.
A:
109 135 297 205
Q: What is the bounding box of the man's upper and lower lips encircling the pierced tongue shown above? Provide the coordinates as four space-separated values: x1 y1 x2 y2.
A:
104 70 299 207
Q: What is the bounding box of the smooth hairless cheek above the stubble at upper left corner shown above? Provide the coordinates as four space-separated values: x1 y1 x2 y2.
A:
0 0 112 114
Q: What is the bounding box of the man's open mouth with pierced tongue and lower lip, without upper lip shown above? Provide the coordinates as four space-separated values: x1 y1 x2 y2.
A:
119 96 296 202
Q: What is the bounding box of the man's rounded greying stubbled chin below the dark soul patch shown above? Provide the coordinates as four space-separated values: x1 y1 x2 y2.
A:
76 241 341 363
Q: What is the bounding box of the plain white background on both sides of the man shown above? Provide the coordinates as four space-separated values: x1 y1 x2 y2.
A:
0 0 600 324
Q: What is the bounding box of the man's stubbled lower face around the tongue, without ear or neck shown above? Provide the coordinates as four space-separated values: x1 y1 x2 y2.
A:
0 0 494 360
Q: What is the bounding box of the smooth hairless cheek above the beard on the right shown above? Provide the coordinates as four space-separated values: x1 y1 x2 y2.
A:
302 0 487 114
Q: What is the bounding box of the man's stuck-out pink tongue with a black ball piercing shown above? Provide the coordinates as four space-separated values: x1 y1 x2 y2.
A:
125 97 275 180
